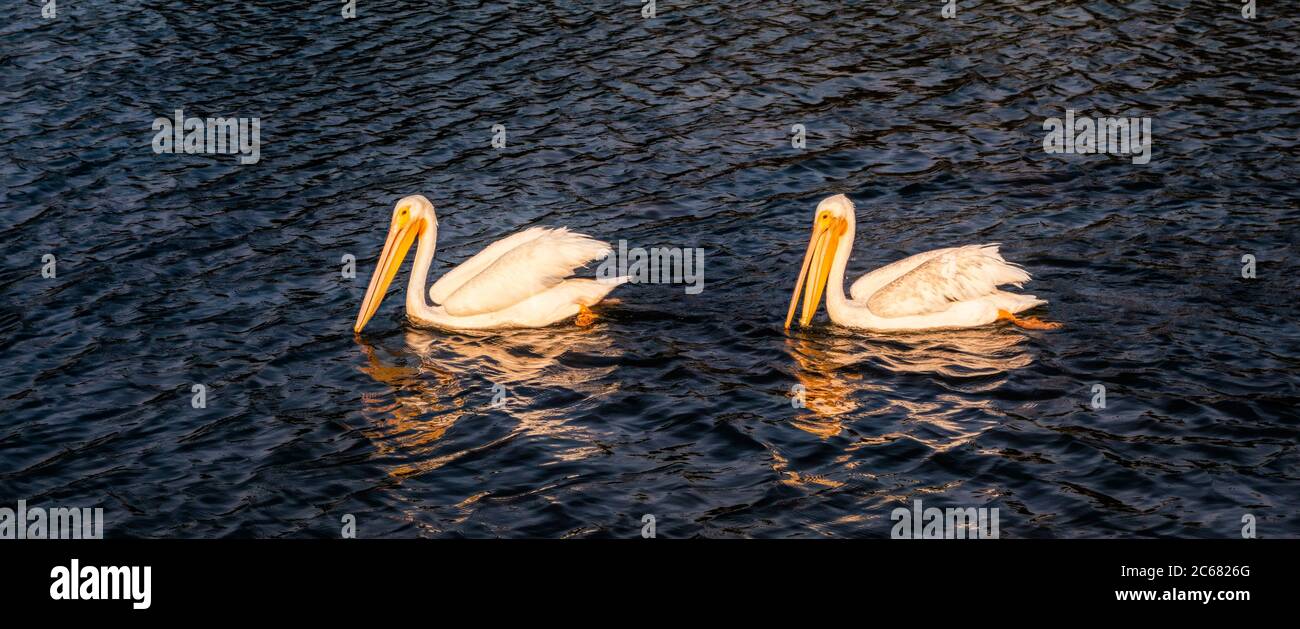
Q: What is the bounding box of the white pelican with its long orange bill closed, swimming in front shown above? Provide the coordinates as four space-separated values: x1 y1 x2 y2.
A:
352 195 627 333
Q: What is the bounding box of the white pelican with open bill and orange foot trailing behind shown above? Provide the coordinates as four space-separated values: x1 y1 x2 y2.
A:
785 195 1061 331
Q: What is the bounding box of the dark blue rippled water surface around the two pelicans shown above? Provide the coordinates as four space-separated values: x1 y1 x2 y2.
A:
0 0 1300 537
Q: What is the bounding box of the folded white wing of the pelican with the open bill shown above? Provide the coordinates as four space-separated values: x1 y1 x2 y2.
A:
867 244 1030 317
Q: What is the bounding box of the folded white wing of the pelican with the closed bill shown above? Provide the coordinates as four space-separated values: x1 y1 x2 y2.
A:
439 227 610 317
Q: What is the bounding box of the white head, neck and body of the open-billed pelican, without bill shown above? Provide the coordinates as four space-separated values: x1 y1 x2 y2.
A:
822 195 1047 331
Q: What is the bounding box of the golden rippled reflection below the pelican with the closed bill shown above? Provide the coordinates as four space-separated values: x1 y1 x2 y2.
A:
356 327 616 477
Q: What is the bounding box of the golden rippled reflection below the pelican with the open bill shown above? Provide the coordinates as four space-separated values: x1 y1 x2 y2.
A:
787 327 1032 450
